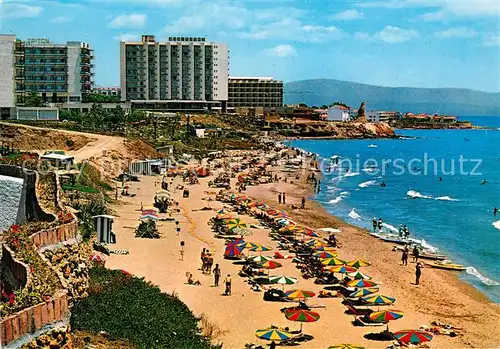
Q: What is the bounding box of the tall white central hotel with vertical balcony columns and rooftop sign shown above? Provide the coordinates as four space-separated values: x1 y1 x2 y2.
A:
120 35 229 110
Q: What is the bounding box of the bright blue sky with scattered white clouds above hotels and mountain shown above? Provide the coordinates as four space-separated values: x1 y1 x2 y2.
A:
0 0 500 92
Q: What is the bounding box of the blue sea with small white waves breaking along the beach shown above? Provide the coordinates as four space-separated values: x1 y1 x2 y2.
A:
291 117 500 302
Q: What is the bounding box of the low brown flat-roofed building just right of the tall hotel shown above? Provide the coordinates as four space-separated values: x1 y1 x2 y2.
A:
228 77 283 108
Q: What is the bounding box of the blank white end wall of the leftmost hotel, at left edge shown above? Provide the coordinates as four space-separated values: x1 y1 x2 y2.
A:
0 35 16 107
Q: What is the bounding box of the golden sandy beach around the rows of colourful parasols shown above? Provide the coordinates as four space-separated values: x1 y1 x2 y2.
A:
106 152 500 348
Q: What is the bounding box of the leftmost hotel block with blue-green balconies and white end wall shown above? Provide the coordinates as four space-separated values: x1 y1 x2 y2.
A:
0 35 94 108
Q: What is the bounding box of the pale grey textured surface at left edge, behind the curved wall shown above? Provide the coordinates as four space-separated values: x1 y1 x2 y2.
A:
0 175 23 231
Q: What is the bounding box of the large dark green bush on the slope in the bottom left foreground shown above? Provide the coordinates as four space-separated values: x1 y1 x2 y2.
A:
71 267 215 349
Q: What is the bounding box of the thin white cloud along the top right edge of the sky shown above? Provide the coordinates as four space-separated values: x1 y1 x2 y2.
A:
356 0 500 17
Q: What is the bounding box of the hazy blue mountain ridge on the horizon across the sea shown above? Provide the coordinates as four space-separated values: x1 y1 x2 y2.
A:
284 79 500 116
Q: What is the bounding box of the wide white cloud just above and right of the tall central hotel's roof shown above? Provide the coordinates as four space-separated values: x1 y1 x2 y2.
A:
239 19 344 42
